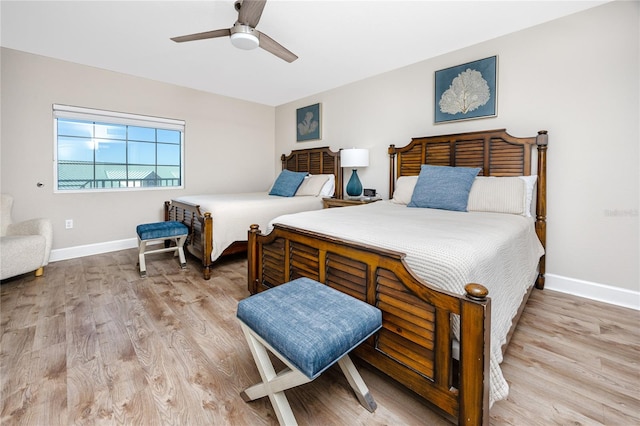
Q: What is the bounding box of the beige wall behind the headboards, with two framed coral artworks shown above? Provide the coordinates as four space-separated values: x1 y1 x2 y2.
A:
276 2 640 296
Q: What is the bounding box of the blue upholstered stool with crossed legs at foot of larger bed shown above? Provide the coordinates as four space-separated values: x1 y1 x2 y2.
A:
237 278 382 425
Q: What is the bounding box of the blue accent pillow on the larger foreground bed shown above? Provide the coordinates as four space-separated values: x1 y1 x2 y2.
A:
407 165 481 212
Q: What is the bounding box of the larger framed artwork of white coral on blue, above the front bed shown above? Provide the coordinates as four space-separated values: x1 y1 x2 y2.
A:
434 56 498 124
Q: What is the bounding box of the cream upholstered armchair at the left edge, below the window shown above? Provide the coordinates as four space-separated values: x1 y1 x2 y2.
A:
0 194 53 280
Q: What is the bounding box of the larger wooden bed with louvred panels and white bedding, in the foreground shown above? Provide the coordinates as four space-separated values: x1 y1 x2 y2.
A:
248 129 547 424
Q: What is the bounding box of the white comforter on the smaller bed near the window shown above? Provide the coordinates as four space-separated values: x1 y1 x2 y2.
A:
175 192 322 262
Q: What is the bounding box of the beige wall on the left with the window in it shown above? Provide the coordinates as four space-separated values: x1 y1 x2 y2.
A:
0 48 279 250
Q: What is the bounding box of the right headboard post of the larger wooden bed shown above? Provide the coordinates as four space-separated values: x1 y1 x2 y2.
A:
536 130 549 290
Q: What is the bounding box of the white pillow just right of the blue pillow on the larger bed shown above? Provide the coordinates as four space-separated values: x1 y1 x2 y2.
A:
467 176 529 216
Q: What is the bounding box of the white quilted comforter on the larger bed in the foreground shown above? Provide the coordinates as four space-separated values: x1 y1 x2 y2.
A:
269 201 544 405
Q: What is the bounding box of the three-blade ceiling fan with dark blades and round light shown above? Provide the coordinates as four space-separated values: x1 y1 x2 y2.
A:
171 0 298 62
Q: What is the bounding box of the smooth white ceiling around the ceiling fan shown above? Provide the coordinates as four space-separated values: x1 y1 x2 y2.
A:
0 0 607 106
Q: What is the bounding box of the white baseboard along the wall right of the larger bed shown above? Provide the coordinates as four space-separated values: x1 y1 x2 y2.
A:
544 274 640 310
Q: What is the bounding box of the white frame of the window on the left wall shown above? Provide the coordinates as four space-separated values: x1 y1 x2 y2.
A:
53 104 186 194
